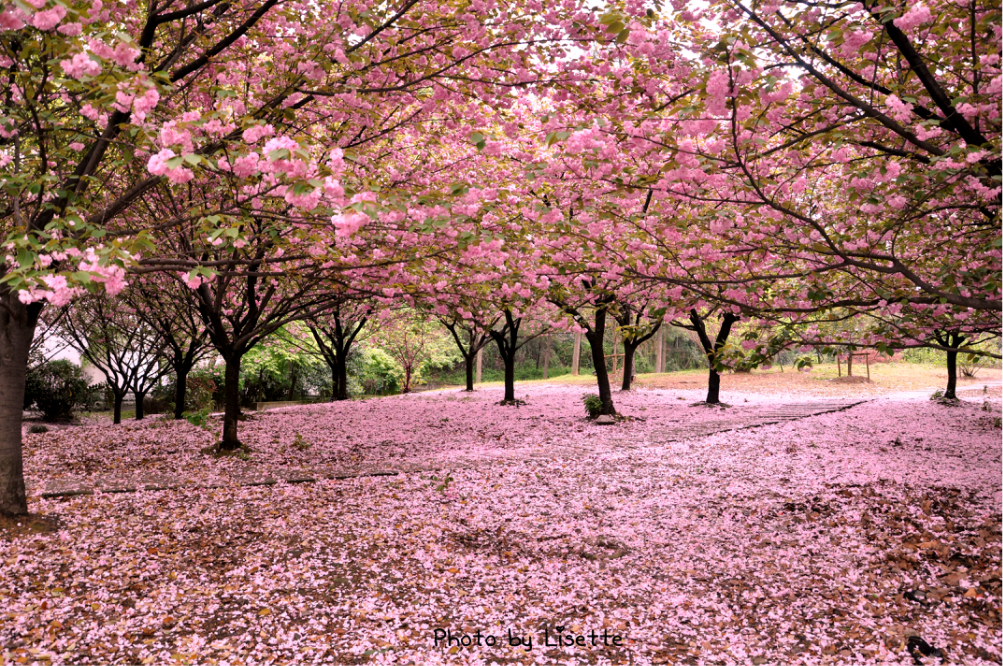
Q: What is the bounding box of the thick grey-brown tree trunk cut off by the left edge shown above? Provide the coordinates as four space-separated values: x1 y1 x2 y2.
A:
0 289 42 516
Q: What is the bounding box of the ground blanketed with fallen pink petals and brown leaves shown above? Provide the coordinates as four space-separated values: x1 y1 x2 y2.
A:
0 373 1001 664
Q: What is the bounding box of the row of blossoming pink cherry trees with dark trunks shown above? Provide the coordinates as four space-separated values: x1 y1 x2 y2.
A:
0 0 1001 514
